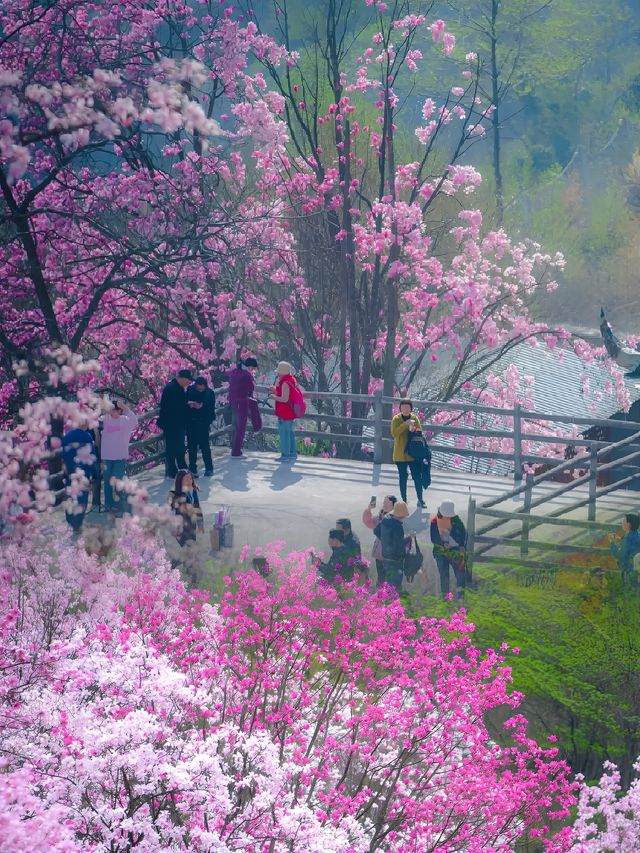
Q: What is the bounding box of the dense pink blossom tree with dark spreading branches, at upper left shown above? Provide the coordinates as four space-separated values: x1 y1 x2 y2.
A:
0 0 291 414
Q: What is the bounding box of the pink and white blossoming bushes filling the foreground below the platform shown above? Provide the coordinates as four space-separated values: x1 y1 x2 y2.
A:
0 521 575 853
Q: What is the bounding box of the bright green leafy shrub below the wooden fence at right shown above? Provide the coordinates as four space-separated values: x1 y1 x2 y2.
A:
460 566 640 775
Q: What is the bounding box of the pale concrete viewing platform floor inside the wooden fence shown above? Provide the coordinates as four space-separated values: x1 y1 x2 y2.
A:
125 448 640 577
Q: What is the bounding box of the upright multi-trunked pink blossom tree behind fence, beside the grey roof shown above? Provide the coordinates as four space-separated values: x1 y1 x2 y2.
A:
239 2 562 399
